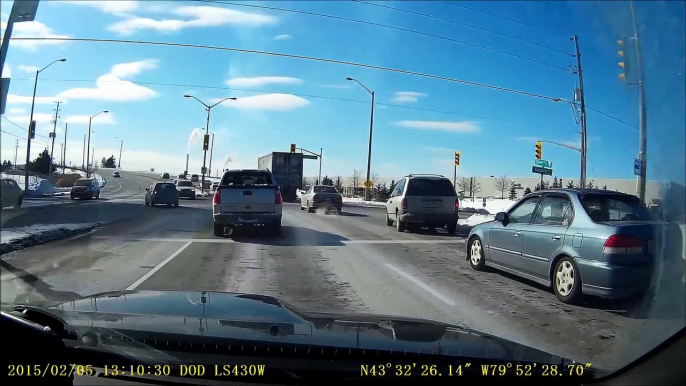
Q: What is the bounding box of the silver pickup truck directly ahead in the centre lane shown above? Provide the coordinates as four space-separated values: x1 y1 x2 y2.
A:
212 169 283 237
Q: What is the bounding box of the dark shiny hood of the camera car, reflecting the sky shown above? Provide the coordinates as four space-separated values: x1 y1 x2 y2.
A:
41 291 566 364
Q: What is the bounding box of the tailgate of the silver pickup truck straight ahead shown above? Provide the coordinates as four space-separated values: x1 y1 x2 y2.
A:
218 186 277 213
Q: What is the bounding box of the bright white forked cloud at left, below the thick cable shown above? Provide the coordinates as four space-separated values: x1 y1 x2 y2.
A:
59 59 157 102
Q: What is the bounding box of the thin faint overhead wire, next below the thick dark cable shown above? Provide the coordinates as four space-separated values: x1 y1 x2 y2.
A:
13 78 513 123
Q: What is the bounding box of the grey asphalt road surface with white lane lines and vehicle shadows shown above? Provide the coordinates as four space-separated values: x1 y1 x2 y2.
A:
0 183 683 368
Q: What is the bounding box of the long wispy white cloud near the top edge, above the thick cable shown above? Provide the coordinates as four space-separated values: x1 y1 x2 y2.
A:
107 6 277 35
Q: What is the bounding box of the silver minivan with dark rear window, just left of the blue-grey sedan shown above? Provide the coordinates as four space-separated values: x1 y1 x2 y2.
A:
386 174 460 234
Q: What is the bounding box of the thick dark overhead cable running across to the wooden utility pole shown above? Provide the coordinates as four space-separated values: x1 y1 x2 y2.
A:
13 37 560 102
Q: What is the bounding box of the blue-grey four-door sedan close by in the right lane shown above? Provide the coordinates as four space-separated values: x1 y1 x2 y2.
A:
467 189 659 303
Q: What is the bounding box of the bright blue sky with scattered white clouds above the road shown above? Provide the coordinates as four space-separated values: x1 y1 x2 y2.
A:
1 1 686 182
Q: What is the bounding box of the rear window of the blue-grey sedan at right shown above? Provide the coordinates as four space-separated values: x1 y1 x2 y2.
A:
581 194 653 222
